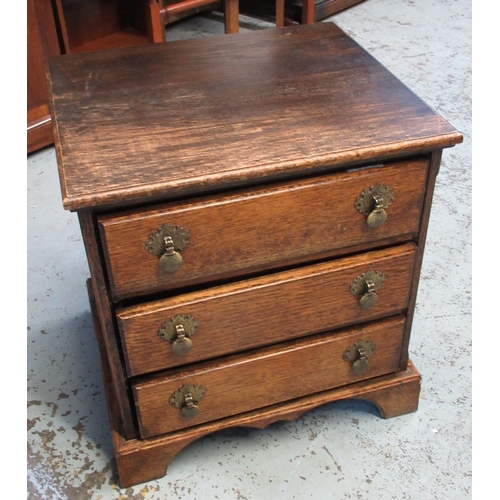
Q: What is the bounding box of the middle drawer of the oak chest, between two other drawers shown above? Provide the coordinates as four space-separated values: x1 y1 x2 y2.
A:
117 243 416 376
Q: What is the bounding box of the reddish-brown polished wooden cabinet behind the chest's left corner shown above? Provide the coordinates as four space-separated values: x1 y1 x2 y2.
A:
27 0 149 153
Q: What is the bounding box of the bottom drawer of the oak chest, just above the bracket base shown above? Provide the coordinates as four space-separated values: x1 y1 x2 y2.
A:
133 316 405 438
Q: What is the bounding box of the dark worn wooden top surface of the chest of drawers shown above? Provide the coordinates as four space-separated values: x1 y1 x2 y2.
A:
48 23 462 210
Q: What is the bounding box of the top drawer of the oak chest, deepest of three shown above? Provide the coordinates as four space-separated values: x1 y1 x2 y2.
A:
99 160 428 300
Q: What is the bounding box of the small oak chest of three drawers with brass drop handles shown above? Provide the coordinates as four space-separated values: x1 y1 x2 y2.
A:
48 23 462 486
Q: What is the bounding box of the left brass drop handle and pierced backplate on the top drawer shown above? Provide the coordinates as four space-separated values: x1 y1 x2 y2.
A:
145 224 191 273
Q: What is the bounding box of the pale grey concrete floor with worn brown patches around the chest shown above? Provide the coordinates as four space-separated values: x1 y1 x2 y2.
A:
27 0 472 500
